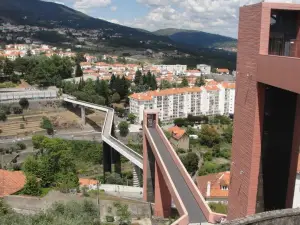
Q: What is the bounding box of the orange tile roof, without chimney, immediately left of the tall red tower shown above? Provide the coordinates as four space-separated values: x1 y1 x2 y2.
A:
197 171 230 198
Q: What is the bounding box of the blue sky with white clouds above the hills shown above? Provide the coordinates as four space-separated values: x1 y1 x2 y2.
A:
44 0 278 38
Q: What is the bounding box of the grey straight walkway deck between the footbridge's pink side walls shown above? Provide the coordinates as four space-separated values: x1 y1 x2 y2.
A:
148 128 207 223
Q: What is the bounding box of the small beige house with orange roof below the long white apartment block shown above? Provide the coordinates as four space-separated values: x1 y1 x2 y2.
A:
168 126 190 150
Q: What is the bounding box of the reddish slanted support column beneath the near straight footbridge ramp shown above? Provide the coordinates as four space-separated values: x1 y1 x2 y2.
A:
154 163 172 218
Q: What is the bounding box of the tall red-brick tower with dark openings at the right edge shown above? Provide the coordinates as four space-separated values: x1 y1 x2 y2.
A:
228 3 300 220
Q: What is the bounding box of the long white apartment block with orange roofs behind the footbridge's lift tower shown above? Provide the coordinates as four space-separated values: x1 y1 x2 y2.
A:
129 82 235 123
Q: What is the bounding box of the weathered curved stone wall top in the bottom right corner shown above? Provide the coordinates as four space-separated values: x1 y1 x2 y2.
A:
224 208 300 225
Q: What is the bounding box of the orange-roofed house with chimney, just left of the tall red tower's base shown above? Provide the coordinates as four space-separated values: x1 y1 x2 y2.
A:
197 171 230 204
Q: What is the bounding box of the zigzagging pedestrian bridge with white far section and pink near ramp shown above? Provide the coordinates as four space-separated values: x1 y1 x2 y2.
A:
64 98 226 225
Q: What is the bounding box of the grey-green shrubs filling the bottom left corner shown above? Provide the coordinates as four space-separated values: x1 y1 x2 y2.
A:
0 200 100 225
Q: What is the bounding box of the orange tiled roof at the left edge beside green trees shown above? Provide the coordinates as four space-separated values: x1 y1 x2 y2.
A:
0 169 26 198
